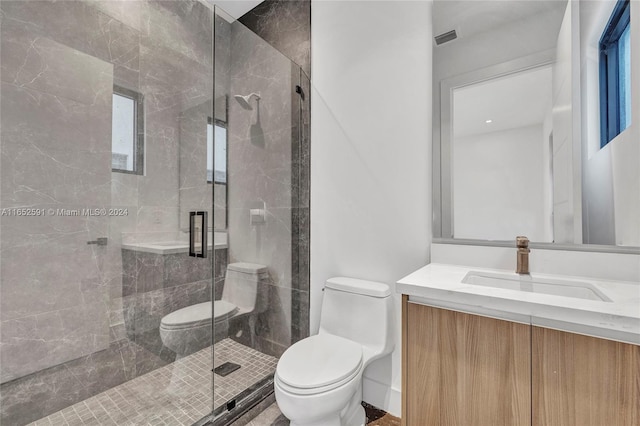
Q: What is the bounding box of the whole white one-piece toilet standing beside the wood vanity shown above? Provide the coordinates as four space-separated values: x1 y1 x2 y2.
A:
274 277 394 426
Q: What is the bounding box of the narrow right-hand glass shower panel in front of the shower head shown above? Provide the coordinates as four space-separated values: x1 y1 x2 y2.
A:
213 8 308 424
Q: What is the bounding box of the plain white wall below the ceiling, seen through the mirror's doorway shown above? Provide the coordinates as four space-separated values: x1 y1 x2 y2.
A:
452 124 550 241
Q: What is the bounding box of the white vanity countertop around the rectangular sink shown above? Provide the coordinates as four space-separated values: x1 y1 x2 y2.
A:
396 263 640 345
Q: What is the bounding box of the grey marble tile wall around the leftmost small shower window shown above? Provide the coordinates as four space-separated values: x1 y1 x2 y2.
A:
0 0 213 424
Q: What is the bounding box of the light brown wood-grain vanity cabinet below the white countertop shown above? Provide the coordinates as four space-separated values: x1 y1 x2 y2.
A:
402 296 640 426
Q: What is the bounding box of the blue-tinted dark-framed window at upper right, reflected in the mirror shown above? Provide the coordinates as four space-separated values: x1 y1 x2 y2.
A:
600 0 631 147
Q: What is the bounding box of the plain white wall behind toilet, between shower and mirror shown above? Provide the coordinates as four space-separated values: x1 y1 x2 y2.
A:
311 0 432 415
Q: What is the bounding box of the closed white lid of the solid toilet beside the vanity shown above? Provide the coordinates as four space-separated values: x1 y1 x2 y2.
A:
276 334 362 389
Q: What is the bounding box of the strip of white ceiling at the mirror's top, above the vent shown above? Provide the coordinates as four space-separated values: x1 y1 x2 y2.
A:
433 0 567 41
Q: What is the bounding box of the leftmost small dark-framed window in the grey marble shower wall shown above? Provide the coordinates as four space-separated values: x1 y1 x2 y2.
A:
111 86 144 175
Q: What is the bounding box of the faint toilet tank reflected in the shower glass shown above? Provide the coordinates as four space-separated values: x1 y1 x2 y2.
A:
222 262 269 312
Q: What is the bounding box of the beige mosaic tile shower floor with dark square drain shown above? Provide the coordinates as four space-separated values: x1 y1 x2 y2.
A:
31 339 278 426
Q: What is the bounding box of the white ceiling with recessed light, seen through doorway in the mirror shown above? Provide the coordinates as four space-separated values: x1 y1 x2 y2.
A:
453 65 552 137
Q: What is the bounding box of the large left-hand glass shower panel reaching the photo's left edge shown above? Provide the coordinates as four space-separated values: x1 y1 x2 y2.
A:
0 0 214 425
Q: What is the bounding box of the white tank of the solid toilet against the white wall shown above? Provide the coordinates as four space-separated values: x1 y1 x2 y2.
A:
320 277 395 358
